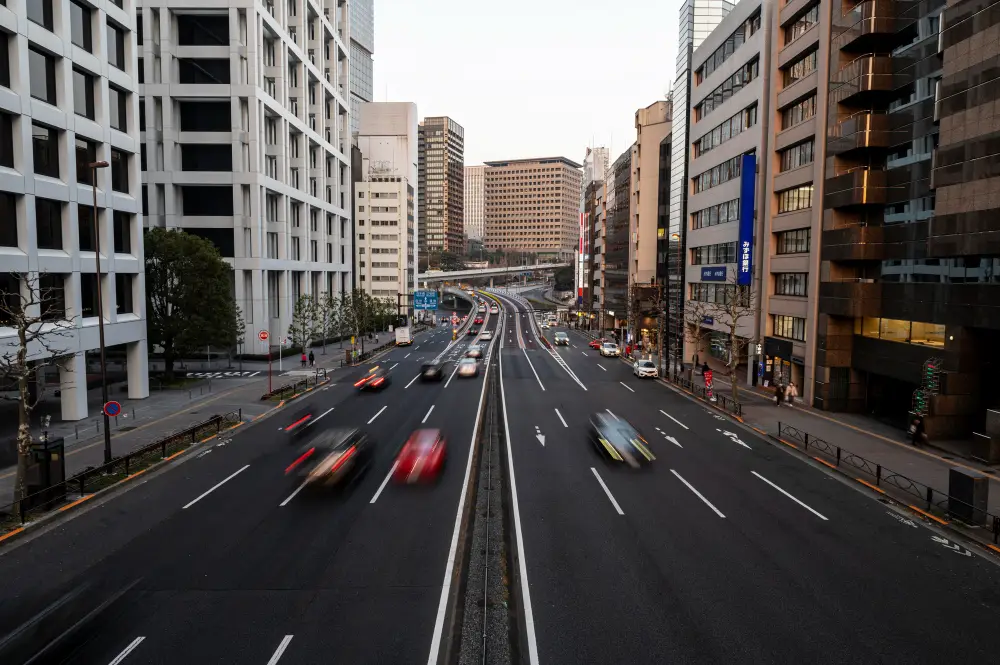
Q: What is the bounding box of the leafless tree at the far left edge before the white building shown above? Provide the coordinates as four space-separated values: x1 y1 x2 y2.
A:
0 273 73 510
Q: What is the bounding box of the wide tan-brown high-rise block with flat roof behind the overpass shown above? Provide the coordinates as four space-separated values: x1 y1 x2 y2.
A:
485 157 582 261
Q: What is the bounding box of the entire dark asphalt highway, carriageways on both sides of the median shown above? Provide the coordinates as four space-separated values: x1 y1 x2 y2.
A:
0 292 1000 665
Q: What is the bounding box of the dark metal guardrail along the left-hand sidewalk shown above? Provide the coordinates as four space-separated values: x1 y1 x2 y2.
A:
0 409 243 535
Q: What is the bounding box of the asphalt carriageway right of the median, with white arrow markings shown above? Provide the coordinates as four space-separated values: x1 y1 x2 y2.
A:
488 290 1000 663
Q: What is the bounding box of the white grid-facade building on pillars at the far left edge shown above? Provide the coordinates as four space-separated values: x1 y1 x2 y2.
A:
0 0 149 420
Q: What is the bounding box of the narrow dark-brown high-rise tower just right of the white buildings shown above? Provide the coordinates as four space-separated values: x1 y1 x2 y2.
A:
418 116 465 256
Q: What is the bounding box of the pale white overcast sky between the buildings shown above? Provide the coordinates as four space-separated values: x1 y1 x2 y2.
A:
374 0 680 165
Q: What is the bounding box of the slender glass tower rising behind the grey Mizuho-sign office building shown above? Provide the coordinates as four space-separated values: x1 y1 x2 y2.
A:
664 0 733 374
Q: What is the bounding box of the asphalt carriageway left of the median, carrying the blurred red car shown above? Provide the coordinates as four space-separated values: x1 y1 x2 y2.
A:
0 302 499 665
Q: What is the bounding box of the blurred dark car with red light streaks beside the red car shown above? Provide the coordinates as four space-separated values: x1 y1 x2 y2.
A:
285 427 375 487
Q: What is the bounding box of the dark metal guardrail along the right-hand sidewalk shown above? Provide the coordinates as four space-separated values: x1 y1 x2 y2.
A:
778 422 1000 544
